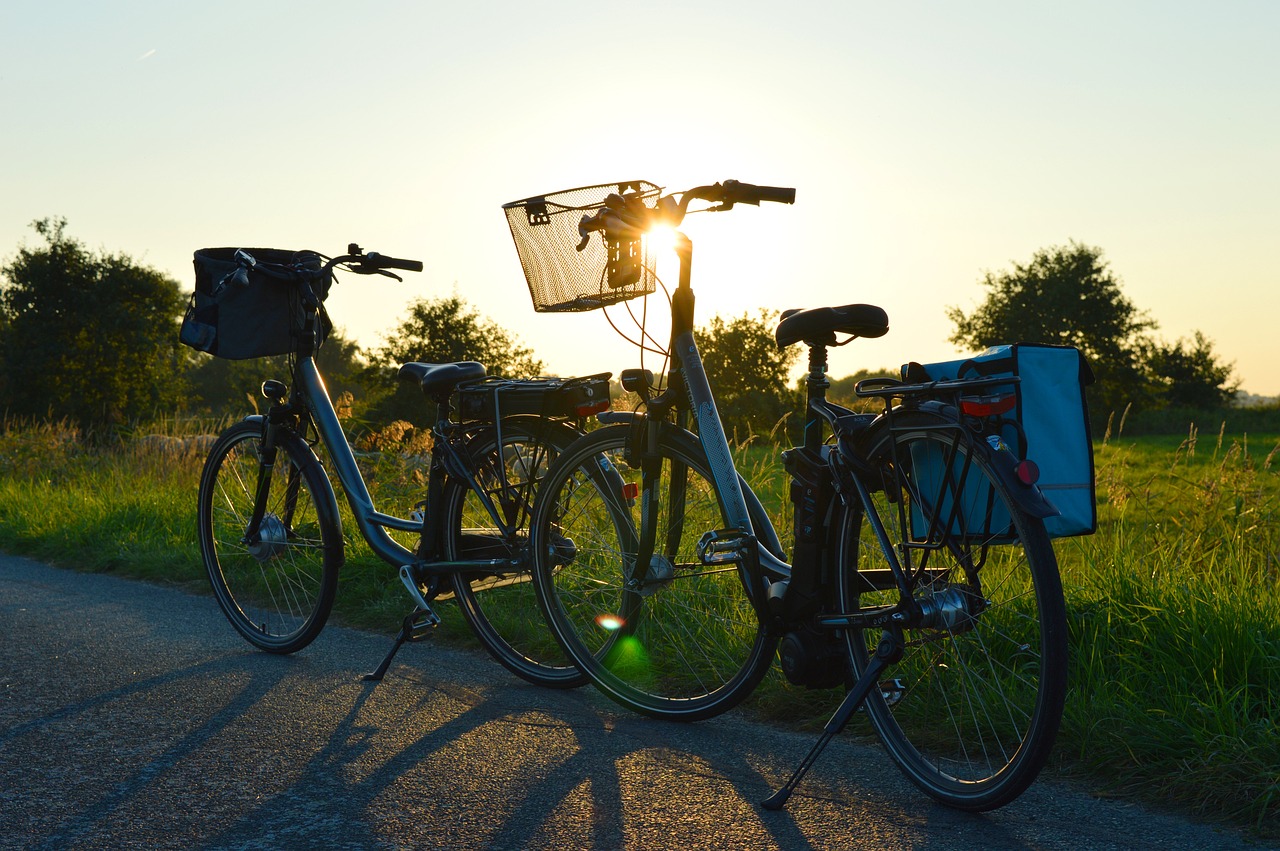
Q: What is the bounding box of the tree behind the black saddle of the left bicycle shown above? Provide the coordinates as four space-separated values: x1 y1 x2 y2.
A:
361 296 543 424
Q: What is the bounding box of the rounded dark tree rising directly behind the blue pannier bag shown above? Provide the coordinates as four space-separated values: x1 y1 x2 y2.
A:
947 241 1156 415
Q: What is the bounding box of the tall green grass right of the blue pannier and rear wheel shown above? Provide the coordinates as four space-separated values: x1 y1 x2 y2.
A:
1057 427 1280 836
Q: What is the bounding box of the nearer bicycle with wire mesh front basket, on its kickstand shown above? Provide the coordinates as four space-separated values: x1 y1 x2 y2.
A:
506 180 1092 810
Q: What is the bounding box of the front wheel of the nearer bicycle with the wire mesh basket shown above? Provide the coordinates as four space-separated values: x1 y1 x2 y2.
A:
531 425 777 720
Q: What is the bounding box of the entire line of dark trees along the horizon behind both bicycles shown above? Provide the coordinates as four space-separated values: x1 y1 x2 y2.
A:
0 219 1238 439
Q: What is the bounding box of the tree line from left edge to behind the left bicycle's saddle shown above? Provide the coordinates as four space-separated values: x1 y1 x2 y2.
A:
0 219 543 435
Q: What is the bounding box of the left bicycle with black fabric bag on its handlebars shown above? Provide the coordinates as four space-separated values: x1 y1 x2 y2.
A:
182 244 609 687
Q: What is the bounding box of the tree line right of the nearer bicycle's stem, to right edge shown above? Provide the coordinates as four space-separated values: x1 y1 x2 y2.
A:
699 241 1239 436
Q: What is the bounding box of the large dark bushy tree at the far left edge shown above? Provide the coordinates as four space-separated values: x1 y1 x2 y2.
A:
0 219 184 429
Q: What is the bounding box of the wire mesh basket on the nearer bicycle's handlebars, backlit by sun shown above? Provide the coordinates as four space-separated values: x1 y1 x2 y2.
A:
502 180 662 314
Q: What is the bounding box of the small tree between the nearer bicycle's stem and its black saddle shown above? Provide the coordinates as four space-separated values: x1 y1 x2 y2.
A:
698 310 803 439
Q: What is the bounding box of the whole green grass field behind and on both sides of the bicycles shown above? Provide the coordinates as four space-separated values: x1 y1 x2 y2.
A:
0 414 1280 837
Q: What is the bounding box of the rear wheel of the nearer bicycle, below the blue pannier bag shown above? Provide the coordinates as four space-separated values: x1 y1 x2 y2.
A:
836 413 1068 811
